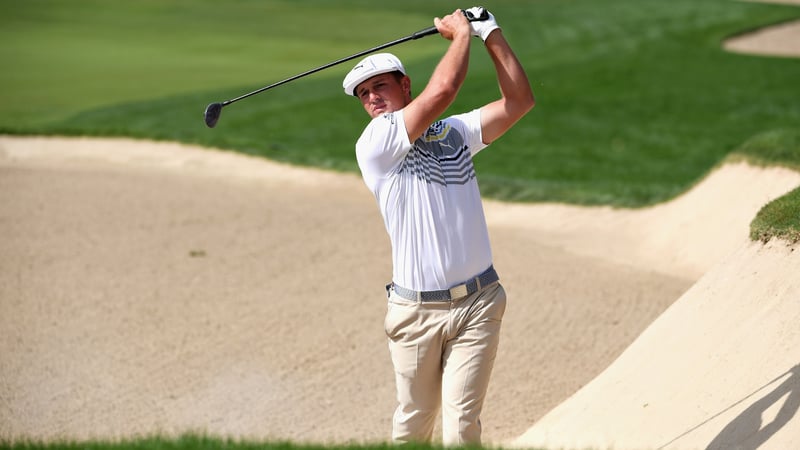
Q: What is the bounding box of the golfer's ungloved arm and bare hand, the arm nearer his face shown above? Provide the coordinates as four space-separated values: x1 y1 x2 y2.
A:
403 10 471 142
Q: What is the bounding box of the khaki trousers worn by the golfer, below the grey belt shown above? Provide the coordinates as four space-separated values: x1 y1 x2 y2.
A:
384 282 506 445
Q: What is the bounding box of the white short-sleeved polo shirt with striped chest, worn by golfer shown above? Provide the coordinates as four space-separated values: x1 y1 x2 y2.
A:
356 109 492 291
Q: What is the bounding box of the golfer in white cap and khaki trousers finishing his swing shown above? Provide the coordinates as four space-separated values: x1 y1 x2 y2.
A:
343 8 534 445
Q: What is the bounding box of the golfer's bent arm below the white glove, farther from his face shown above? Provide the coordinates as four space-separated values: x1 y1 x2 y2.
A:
481 28 535 144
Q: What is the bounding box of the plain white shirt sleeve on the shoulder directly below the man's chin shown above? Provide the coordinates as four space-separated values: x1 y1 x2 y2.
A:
356 110 411 187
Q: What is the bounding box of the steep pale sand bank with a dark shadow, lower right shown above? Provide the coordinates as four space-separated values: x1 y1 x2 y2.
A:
514 237 800 449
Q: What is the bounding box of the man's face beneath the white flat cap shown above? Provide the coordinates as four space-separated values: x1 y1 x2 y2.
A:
355 73 411 119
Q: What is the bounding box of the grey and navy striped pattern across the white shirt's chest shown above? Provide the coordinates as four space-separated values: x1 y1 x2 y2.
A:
399 121 475 186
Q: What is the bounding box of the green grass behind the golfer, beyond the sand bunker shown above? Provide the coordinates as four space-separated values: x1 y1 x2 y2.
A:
0 0 800 225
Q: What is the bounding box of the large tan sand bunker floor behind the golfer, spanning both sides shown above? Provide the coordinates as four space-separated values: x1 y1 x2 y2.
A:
0 137 800 443
